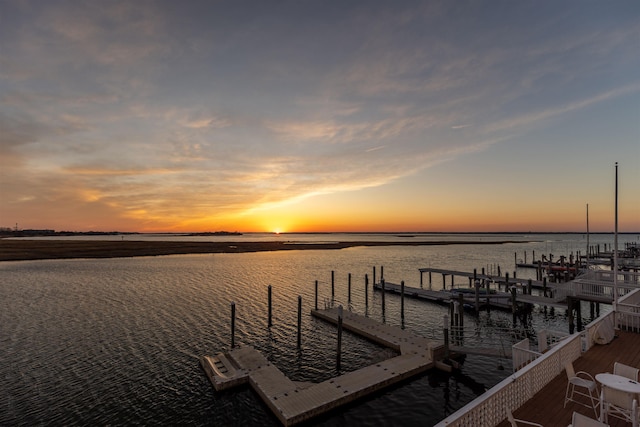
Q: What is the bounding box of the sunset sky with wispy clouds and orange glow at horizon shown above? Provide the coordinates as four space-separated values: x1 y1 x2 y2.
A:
0 0 640 232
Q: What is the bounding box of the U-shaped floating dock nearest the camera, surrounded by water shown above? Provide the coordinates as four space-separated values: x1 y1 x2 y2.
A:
201 308 444 426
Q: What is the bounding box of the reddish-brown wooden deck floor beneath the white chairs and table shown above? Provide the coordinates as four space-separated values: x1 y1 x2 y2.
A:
498 331 640 427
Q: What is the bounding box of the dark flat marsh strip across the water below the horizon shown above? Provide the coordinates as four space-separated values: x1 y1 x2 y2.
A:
0 239 525 261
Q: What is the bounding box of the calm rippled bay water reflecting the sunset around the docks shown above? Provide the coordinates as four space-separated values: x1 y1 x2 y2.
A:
0 235 637 426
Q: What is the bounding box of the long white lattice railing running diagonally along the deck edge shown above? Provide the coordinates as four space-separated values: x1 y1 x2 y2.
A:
436 312 614 427
